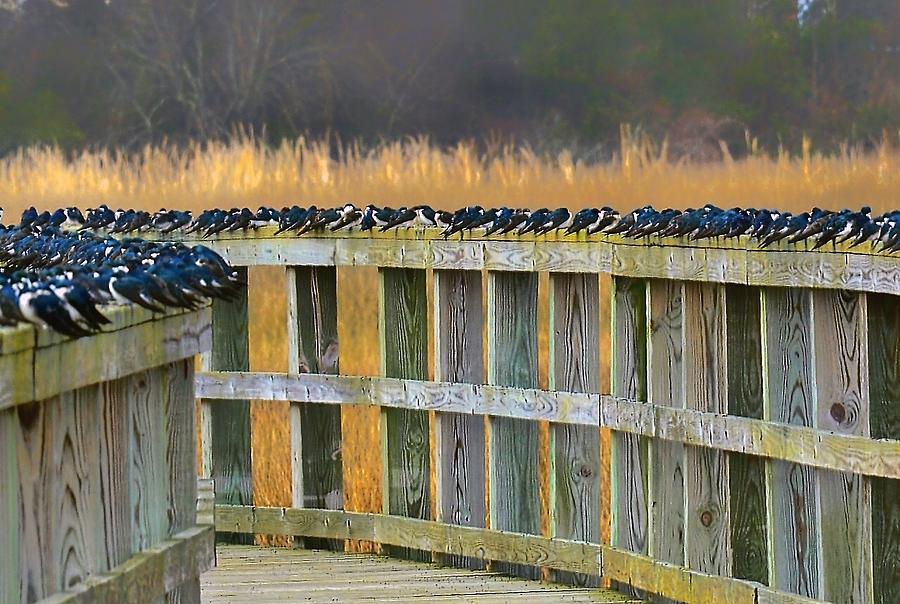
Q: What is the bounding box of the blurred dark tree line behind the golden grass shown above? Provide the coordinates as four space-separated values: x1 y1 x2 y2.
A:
0 0 900 159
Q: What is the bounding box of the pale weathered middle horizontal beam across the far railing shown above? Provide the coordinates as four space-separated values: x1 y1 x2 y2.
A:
196 372 900 479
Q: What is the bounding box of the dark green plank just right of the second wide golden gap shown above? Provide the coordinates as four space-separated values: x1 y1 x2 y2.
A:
379 269 431 559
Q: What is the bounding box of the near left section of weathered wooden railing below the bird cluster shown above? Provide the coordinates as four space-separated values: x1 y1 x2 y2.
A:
0 307 215 603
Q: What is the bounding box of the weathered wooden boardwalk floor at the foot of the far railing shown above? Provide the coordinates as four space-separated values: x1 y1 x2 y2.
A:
201 546 633 604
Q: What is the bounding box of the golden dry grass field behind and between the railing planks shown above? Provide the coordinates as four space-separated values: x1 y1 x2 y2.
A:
0 129 900 540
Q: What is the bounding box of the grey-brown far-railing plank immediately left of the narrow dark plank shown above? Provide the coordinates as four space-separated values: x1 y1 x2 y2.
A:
684 283 732 576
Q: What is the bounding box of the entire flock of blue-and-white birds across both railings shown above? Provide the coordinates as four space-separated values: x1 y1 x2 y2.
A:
0 204 900 337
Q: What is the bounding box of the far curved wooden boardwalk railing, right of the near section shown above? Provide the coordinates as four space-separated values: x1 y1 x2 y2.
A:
179 229 900 603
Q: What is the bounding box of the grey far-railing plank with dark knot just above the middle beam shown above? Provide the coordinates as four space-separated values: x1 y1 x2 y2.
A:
812 290 873 602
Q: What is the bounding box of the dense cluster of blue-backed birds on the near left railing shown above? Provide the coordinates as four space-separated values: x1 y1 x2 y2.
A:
0 210 244 338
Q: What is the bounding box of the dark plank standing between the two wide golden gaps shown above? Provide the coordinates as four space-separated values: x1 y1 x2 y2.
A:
287 267 344 550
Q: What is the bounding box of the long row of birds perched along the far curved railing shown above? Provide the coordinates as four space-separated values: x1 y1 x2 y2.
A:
12 204 900 253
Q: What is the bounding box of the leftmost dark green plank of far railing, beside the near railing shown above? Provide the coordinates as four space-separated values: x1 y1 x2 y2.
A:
204 268 253 542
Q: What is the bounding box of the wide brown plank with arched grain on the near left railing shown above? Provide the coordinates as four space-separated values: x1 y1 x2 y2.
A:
17 387 106 602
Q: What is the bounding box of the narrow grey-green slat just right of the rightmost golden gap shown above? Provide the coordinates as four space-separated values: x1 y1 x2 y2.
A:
611 277 648 596
